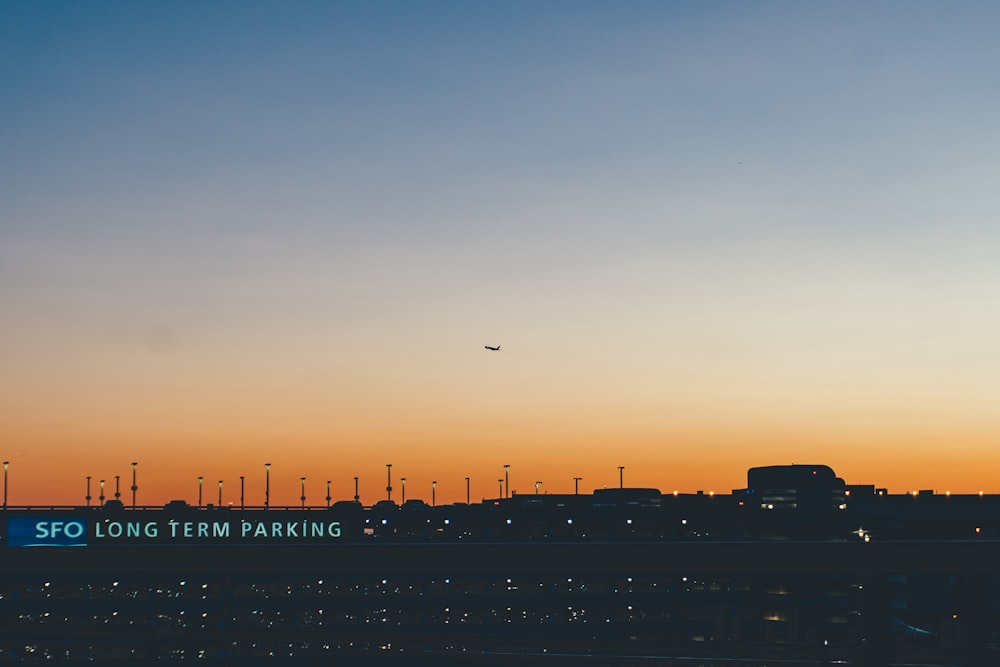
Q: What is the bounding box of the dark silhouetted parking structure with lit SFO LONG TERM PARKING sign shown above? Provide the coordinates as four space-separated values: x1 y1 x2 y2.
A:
0 466 1000 667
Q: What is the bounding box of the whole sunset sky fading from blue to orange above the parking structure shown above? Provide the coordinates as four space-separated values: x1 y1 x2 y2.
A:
0 0 1000 504
